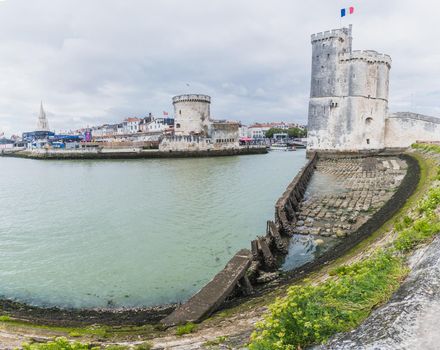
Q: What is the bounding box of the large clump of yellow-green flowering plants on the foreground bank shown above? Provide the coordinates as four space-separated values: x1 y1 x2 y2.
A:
250 251 406 350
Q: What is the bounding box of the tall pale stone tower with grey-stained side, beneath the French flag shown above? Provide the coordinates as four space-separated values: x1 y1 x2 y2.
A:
307 25 391 151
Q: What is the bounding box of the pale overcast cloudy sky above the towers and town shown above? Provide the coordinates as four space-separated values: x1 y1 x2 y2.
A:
0 0 440 135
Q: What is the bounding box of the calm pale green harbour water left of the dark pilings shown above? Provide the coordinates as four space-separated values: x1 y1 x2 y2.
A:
0 151 305 308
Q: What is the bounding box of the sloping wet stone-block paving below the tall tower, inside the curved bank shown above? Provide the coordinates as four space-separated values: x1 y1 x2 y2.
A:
294 157 407 238
